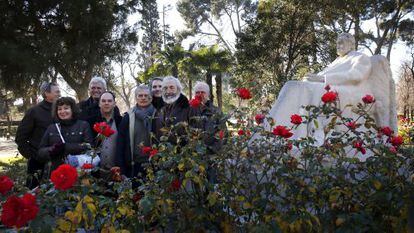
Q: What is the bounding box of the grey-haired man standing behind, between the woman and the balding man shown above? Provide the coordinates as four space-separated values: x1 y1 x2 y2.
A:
79 77 119 120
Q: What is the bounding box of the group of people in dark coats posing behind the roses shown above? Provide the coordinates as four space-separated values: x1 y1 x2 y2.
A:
15 76 223 188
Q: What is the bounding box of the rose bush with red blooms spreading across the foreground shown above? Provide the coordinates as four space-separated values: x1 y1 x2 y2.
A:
2 88 414 232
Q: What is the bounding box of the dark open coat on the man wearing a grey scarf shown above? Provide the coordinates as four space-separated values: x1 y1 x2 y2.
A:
115 106 156 177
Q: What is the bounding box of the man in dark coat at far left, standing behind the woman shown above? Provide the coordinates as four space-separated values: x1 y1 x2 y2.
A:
15 83 60 189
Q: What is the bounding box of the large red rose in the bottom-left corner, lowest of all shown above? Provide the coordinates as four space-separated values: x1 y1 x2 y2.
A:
1 193 39 228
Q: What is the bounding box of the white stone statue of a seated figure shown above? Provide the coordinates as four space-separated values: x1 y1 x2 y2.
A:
265 33 397 145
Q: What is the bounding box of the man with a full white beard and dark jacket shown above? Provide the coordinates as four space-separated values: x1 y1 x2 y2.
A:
155 76 190 143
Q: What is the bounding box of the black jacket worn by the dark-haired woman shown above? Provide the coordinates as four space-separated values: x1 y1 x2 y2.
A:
36 120 92 175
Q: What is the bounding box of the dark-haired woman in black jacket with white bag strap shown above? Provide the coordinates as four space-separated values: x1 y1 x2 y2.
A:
36 97 92 177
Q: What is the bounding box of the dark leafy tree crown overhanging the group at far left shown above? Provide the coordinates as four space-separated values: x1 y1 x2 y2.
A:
0 0 137 99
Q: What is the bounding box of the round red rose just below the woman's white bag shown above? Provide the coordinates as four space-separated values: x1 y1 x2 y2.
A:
50 164 78 191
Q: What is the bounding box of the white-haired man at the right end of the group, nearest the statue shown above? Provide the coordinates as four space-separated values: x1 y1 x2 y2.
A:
189 82 226 153
